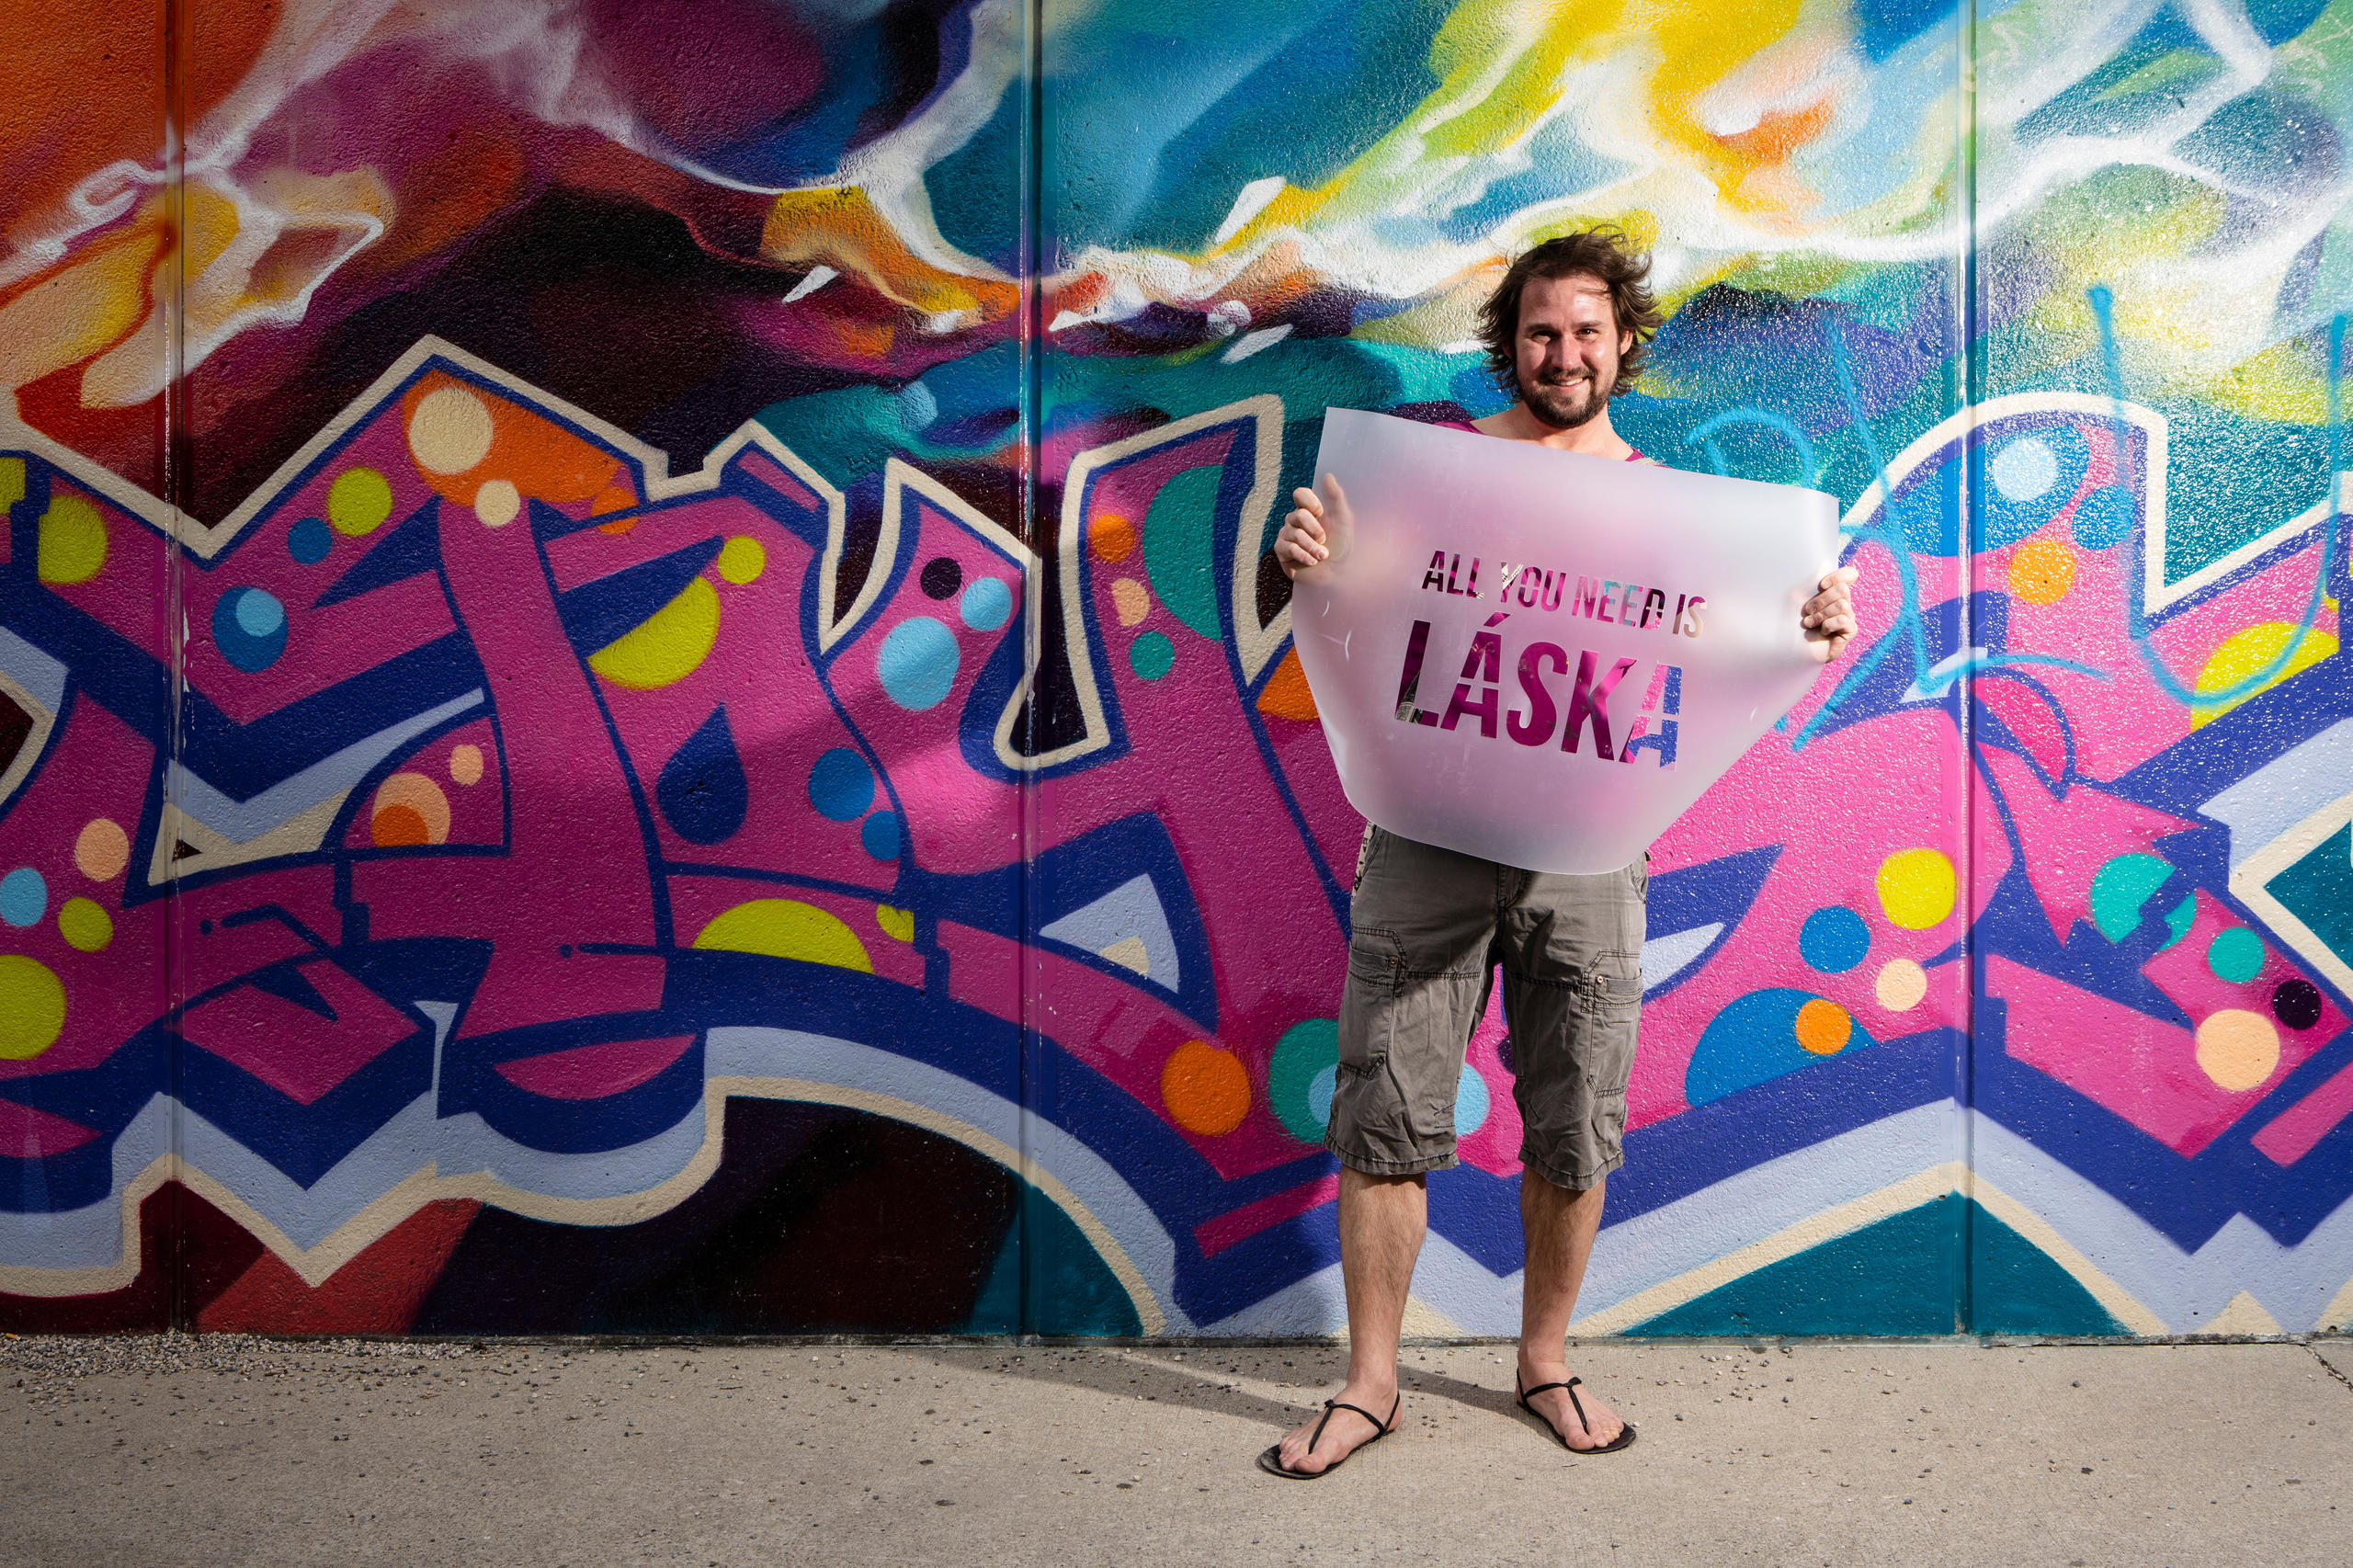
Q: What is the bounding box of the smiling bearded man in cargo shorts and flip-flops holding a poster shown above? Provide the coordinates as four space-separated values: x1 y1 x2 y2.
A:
1259 228 1854 1479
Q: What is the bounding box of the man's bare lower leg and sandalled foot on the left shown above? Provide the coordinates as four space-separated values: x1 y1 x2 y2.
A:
1282 1165 1430 1471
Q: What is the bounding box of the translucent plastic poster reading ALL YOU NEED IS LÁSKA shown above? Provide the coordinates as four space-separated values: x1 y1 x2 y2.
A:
1291 410 1837 871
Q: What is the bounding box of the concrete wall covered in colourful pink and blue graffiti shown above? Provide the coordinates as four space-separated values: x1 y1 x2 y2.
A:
0 0 2353 1335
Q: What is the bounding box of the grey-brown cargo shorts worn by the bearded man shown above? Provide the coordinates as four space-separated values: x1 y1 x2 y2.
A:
1324 826 1650 1189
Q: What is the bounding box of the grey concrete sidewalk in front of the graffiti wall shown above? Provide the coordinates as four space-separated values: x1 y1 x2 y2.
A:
0 1337 2353 1568
